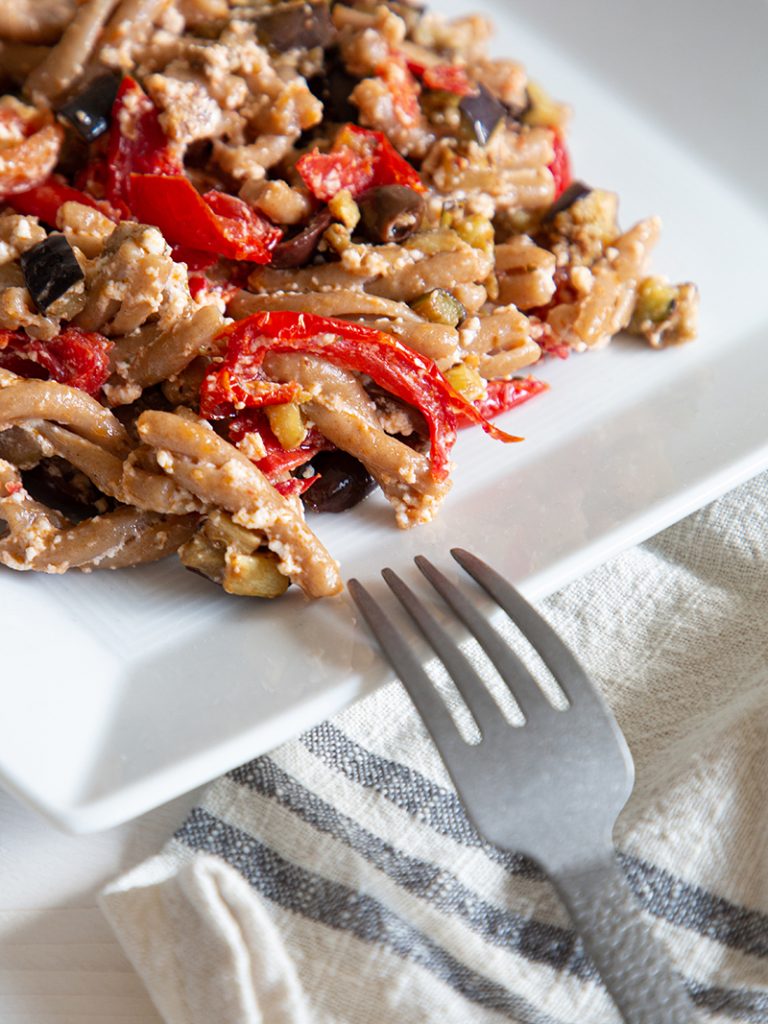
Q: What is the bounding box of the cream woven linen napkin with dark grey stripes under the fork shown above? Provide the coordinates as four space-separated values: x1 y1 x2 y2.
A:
102 474 768 1024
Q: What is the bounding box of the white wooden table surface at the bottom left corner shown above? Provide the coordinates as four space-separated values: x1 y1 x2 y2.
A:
0 791 200 1024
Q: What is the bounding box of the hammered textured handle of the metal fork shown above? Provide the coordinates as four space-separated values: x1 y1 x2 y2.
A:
551 851 698 1024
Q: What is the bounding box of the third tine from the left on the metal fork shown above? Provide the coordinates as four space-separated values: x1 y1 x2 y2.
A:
415 555 552 719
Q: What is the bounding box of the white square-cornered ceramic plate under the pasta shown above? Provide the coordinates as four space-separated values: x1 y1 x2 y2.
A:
0 0 768 830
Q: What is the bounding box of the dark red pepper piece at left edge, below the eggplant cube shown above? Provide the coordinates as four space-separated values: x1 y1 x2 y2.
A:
0 327 114 395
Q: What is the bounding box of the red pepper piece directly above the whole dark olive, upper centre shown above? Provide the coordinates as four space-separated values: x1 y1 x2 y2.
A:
296 124 426 203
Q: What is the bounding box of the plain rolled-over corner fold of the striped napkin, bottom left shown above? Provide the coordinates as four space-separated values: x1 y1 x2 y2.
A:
99 853 311 1024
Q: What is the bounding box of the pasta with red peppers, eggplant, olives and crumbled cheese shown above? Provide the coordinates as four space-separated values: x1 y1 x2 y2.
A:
0 0 697 597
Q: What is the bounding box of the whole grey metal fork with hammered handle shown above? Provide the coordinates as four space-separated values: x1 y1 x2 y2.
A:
349 548 697 1024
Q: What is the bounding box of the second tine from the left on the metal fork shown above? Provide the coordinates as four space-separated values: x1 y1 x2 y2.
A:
381 569 504 735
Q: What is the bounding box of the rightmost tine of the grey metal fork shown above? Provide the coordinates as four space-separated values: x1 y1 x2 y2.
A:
451 548 602 707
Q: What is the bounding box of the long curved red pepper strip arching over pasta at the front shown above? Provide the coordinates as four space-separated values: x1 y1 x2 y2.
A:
203 310 522 480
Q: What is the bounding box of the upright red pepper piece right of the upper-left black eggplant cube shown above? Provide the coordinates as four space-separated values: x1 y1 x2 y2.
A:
106 76 182 215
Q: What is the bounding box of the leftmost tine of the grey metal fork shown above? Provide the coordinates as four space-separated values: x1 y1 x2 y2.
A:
347 580 466 761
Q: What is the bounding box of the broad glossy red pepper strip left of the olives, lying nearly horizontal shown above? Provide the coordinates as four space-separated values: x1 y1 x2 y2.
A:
130 174 283 263
